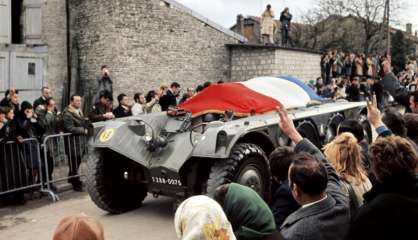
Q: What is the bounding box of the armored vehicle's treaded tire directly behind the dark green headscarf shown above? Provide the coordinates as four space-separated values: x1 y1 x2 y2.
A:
206 143 271 200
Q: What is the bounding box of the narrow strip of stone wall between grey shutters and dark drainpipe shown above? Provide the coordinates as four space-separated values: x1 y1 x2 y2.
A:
42 0 67 106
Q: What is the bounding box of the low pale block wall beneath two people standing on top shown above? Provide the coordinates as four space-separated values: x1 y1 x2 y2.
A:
228 44 321 81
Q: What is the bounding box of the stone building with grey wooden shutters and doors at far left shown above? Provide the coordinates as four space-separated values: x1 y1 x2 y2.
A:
0 0 67 106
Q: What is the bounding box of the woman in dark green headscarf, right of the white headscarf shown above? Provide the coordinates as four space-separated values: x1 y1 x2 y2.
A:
215 183 281 240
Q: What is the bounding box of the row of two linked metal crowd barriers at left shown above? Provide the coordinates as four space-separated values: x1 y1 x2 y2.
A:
0 133 88 202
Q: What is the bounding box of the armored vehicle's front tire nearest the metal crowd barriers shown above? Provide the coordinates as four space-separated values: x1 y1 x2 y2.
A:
86 150 147 214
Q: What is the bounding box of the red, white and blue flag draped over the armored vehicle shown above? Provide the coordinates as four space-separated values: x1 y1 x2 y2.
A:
178 76 323 117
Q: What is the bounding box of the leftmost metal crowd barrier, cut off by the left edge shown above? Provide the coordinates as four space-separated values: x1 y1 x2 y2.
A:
0 138 54 202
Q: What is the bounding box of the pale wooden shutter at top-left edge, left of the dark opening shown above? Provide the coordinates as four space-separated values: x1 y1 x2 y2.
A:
0 0 12 44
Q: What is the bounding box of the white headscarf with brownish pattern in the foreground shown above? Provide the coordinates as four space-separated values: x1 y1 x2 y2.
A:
174 196 236 240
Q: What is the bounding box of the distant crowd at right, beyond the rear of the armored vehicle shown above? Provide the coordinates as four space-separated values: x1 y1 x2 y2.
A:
316 50 418 110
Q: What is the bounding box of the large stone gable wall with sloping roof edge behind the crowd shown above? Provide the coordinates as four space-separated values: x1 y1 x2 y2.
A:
72 0 242 102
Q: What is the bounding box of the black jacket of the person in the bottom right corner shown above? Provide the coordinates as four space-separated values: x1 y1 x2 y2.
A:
348 177 418 240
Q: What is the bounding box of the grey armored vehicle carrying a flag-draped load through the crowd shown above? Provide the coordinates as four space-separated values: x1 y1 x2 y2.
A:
87 77 371 213
